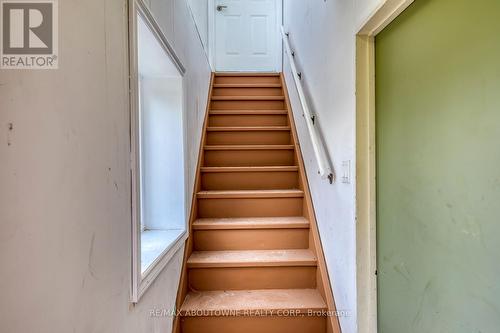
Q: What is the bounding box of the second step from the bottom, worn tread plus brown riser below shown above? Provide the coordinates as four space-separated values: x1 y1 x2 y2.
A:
186 249 317 291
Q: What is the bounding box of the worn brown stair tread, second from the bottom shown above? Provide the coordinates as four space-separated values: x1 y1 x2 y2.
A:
187 250 316 268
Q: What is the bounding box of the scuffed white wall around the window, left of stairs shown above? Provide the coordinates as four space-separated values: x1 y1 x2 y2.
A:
0 0 210 333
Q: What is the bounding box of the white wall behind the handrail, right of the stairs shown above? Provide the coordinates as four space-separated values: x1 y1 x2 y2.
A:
283 0 384 333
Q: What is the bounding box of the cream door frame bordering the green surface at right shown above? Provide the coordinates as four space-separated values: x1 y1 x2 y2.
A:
355 0 415 333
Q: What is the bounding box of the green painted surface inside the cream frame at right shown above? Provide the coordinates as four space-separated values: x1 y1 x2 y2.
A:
376 0 500 333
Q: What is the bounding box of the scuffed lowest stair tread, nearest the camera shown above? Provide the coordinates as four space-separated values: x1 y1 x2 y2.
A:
181 289 326 316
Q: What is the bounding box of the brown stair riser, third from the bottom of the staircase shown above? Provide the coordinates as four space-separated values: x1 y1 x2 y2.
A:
194 229 309 251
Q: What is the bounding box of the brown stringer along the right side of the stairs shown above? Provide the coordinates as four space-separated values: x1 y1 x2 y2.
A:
280 73 341 333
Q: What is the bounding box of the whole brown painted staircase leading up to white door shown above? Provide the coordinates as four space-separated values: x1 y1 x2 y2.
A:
174 74 340 333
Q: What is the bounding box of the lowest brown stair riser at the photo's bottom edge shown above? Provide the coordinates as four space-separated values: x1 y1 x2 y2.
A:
181 316 326 333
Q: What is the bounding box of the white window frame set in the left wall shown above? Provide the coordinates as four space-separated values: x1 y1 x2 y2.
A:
129 0 189 303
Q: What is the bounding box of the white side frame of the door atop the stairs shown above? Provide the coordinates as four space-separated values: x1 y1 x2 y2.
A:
208 0 283 73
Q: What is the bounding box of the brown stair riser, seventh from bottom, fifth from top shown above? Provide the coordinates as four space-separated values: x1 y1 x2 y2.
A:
207 131 291 145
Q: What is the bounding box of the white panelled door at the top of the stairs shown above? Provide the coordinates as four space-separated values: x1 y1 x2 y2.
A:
214 0 279 71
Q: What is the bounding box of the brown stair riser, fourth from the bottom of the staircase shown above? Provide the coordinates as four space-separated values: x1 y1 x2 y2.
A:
198 198 302 218
